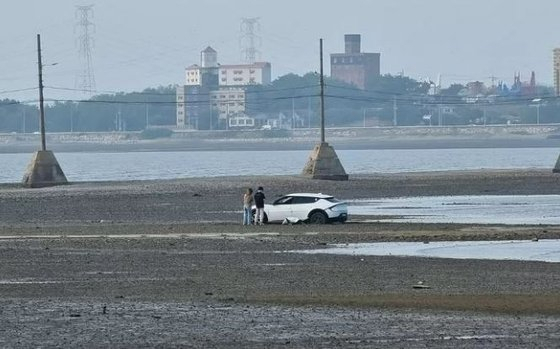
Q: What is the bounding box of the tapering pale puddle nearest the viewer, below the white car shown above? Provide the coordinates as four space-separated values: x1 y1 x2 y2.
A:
296 239 560 263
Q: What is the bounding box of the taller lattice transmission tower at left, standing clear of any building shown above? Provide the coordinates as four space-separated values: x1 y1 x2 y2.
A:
75 5 95 94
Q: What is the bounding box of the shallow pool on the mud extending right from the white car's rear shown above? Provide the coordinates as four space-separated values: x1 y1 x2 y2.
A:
348 195 560 225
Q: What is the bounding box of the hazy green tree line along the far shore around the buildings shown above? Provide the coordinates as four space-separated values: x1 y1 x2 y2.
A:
0 73 560 133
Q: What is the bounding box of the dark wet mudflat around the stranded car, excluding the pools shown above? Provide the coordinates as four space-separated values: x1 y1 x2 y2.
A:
0 170 560 348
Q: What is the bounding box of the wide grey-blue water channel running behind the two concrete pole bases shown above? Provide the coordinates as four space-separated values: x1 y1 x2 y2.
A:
0 148 558 183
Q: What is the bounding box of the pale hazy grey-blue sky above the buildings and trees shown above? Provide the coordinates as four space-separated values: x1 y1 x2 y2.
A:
0 0 560 99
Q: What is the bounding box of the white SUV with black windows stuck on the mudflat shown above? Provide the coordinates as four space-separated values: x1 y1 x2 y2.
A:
253 193 348 224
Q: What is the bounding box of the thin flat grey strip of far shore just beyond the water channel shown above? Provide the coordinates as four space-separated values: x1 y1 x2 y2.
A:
0 136 560 154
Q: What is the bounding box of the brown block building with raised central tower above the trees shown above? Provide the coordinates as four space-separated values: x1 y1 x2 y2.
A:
331 34 381 89
